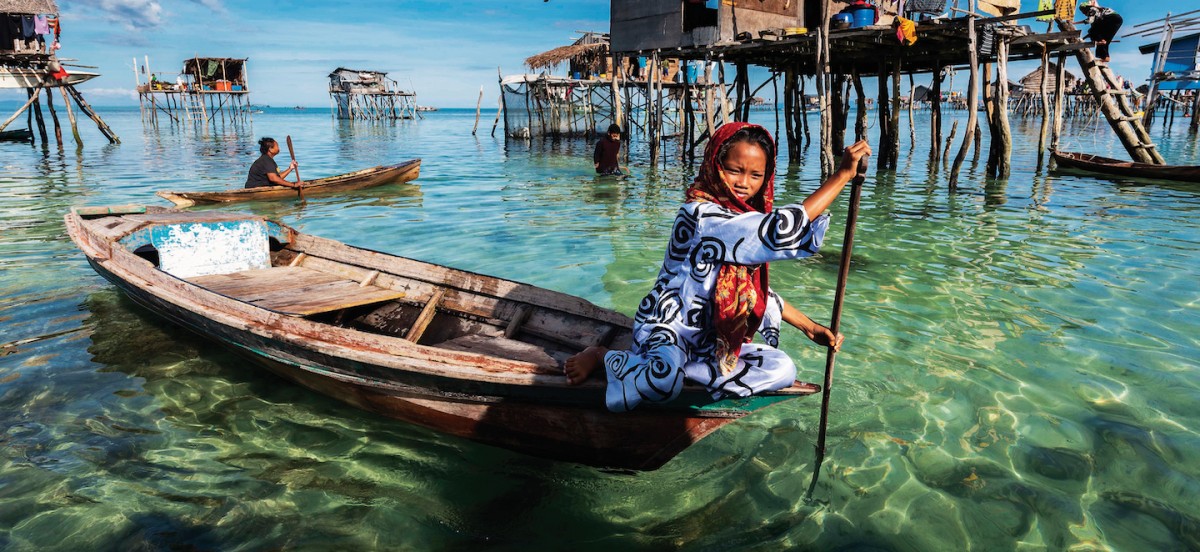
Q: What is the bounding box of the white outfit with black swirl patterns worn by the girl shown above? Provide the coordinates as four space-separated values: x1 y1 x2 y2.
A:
604 202 829 412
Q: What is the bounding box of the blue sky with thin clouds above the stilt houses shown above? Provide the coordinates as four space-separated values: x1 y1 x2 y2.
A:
0 0 1180 108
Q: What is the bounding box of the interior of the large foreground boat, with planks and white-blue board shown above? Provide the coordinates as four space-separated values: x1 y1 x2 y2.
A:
109 214 630 373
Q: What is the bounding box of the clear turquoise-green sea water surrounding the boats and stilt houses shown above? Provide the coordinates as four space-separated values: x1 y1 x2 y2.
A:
0 109 1200 551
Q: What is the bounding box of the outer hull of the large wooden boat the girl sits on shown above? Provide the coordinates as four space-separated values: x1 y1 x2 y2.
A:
67 207 818 469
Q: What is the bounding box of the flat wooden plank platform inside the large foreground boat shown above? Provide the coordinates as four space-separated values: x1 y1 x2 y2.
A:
187 266 404 317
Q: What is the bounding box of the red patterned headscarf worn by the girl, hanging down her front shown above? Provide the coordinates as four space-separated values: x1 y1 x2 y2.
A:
685 122 775 373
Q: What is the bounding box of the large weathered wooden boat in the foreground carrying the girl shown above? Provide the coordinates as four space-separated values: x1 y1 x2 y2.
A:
66 206 820 469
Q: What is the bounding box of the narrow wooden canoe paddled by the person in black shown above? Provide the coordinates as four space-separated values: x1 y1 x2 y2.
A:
157 160 421 208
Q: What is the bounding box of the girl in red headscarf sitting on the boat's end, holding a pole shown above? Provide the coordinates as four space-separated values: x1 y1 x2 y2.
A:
563 122 871 412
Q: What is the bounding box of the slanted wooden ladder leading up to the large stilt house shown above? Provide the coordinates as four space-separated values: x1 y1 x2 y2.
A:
1056 19 1166 164
